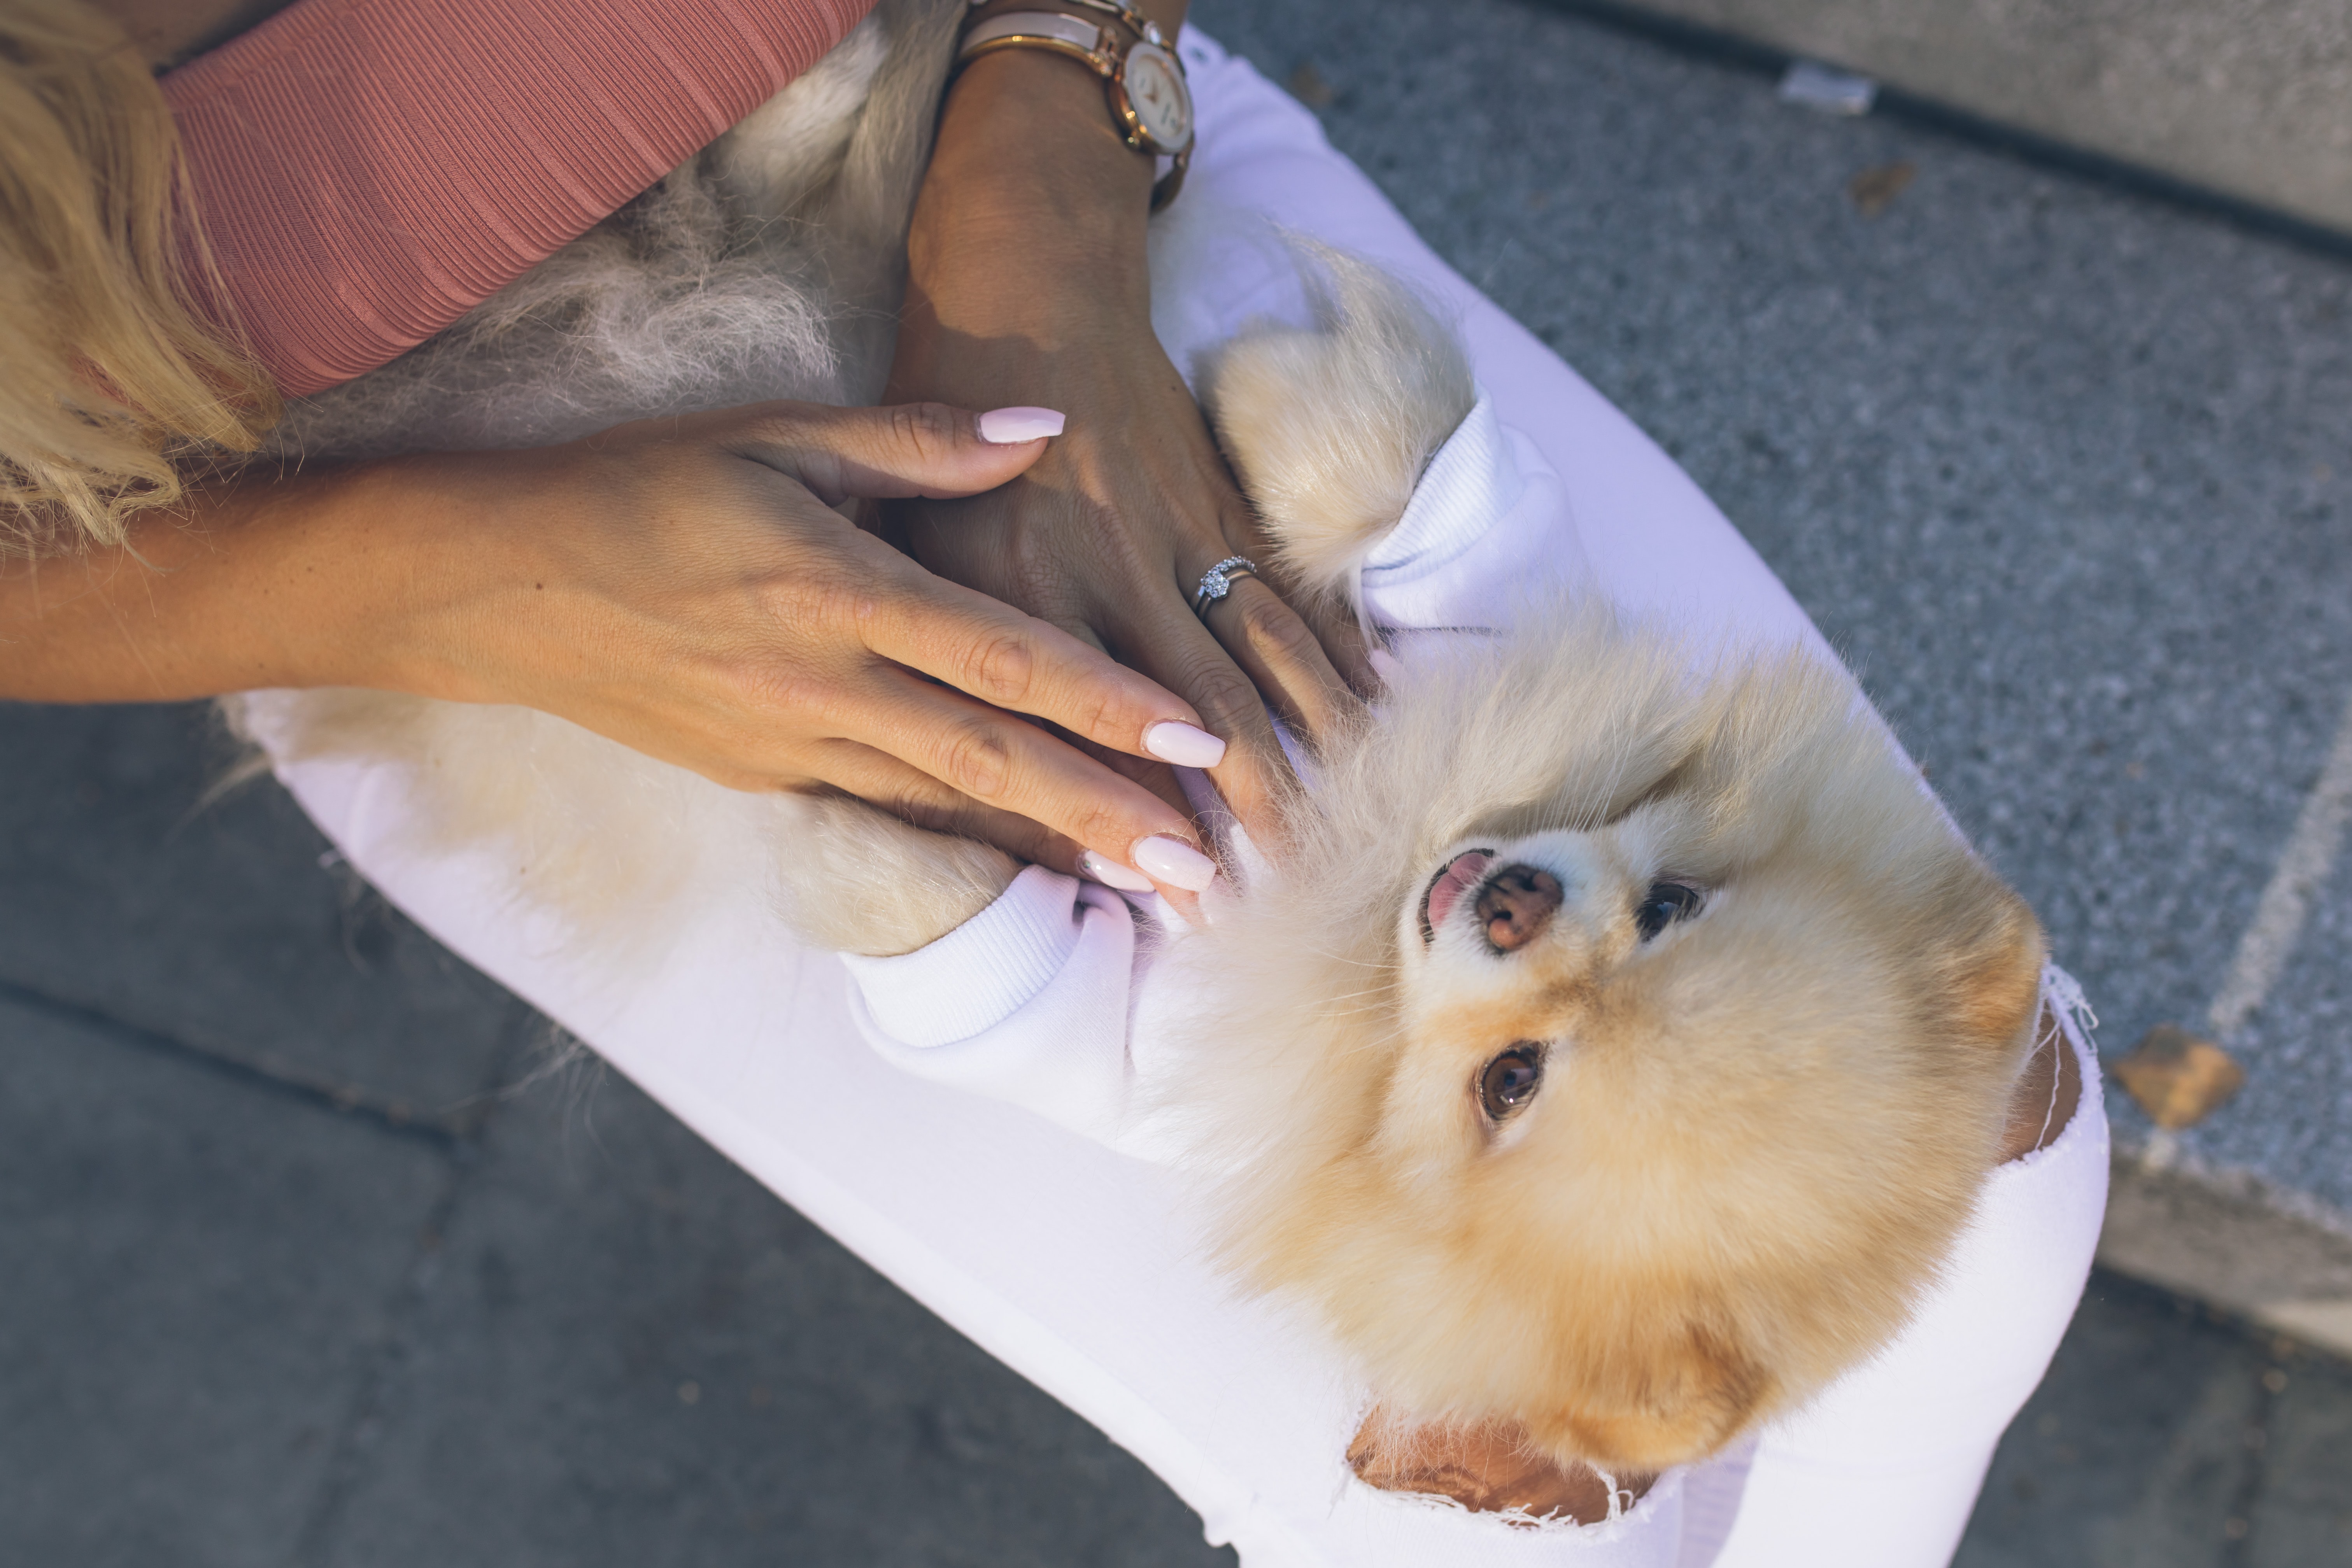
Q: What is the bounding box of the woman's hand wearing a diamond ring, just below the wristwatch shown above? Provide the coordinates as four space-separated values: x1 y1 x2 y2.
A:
889 19 1369 839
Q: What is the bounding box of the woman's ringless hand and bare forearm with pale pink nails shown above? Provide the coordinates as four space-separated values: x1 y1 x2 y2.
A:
0 402 1214 888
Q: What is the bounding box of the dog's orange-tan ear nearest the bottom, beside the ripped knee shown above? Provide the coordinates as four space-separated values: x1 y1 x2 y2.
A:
1527 1326 1774 1474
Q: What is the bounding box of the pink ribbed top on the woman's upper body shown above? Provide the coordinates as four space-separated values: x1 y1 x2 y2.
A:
162 0 873 395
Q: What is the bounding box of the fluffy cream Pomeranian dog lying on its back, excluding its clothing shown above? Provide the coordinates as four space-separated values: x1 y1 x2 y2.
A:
245 0 2044 1472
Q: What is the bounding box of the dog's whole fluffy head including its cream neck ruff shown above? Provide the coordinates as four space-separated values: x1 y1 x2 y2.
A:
1185 620 2042 1469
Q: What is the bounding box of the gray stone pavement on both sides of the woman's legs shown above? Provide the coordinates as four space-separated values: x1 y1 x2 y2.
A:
0 0 2352 1568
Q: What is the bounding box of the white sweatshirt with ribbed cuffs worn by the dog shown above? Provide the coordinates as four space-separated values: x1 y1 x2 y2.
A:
842 395 1585 1156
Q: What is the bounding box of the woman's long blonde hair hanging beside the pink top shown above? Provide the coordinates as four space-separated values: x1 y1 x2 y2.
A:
0 0 280 557
